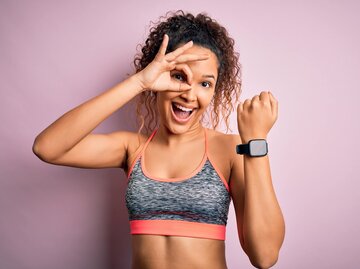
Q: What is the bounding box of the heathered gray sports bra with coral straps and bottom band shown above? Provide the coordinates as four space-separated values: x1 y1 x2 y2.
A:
125 128 231 240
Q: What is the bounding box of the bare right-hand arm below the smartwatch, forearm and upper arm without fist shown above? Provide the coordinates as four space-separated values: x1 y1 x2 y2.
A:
230 136 285 268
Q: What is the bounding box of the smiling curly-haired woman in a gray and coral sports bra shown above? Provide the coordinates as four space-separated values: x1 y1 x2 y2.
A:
33 11 284 269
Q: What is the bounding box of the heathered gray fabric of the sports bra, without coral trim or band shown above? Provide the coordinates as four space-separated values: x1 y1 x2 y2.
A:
125 157 231 225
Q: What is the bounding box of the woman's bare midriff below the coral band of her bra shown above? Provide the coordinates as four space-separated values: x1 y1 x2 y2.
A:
131 232 227 269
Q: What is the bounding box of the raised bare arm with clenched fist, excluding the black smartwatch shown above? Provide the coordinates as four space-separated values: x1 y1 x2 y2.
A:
230 92 285 268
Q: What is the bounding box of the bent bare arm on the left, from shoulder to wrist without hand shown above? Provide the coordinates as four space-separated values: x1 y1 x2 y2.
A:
33 75 143 168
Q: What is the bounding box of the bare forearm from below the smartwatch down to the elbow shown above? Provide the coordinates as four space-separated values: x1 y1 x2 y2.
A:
243 155 285 268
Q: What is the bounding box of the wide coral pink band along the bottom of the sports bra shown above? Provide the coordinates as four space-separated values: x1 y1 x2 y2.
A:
130 220 226 240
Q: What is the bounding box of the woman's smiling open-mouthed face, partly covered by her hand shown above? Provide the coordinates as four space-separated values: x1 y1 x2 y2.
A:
157 45 218 134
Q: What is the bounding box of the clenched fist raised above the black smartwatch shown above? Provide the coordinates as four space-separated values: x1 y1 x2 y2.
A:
237 91 278 143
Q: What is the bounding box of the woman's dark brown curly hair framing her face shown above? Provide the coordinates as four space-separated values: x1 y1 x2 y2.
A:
134 10 241 134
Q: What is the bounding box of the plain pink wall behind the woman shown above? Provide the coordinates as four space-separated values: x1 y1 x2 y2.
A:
0 0 360 269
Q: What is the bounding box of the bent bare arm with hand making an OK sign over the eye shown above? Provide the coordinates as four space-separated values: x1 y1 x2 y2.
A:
33 35 208 168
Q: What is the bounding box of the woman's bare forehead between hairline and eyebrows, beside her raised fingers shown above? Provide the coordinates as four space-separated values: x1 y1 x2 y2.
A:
184 45 219 77
